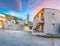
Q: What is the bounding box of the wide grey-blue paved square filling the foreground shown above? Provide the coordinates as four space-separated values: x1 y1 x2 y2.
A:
0 31 60 46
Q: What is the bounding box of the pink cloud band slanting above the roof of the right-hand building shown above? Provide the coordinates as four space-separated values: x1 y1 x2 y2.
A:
32 0 60 15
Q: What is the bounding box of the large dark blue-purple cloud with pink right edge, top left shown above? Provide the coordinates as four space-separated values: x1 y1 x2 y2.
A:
0 0 22 11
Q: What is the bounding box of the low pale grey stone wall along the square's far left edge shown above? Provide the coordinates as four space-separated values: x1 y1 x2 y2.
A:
4 23 24 30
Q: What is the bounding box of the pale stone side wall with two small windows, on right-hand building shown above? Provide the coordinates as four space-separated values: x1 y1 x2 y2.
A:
44 9 60 34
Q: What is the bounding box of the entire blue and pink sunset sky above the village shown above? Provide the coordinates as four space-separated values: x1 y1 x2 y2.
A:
0 0 60 21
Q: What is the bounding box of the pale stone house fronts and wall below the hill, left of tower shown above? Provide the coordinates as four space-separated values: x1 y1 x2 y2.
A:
4 20 25 30
